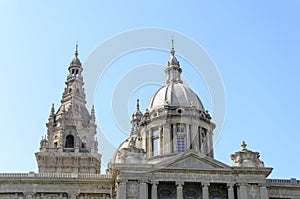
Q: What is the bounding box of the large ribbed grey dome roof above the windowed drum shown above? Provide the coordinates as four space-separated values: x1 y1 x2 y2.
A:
148 82 204 111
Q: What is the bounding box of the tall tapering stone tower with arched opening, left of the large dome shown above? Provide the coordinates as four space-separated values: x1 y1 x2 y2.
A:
35 44 101 174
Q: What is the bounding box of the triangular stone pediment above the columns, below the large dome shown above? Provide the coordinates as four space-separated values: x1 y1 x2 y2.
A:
159 152 230 170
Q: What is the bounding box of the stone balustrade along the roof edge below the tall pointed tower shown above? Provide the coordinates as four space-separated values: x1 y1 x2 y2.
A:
0 172 111 180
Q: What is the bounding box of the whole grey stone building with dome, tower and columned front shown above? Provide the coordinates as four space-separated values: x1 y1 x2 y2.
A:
0 42 300 199
